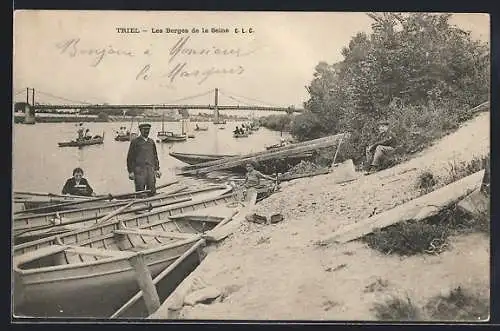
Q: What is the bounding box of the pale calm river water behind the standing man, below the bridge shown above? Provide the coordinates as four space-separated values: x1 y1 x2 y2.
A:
12 122 290 194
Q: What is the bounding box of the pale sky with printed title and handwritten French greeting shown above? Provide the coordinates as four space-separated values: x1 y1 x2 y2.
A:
13 10 490 108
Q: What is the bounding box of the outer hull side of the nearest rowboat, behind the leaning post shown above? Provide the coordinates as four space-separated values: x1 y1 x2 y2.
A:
14 236 196 317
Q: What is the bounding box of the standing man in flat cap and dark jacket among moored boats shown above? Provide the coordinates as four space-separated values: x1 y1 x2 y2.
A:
127 123 161 195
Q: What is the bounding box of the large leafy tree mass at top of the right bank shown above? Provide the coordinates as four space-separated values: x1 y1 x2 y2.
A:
300 13 490 161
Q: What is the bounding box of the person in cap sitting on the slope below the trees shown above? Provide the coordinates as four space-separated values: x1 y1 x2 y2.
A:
366 121 396 174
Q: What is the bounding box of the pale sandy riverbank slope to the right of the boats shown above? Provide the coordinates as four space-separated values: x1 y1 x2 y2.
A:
152 113 490 320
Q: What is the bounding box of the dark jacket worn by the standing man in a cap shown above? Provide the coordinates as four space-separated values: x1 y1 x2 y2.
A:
127 136 160 173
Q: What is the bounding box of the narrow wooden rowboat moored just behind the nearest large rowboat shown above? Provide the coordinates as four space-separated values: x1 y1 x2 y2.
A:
13 185 232 244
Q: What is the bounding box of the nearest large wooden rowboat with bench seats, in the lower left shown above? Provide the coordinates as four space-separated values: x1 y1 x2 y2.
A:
14 194 255 317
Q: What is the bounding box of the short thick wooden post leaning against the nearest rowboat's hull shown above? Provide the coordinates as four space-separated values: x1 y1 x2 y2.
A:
129 253 160 315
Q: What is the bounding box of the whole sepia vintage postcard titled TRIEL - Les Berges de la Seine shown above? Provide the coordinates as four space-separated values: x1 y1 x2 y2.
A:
12 10 490 322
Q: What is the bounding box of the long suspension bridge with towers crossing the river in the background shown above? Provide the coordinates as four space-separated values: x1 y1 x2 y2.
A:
14 87 303 121
